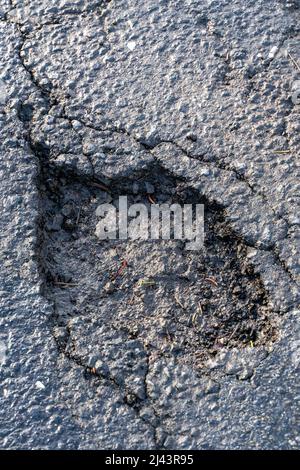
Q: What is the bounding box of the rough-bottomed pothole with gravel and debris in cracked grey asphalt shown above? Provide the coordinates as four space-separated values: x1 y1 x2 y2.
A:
40 156 276 380
